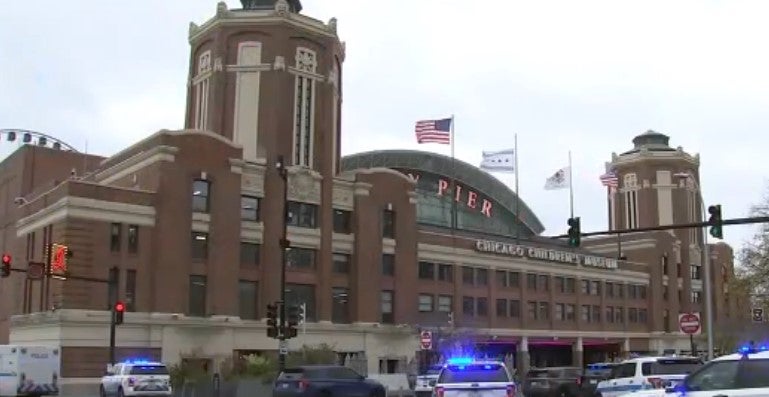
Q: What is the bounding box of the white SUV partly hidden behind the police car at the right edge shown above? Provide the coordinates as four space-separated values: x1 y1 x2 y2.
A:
595 356 703 397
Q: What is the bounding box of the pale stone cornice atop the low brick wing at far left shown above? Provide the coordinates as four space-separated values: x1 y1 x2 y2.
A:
16 196 155 237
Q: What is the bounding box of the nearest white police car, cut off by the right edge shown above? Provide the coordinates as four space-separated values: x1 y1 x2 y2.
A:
622 344 769 397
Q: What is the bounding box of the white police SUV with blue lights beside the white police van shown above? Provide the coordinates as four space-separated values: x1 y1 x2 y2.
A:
99 360 172 397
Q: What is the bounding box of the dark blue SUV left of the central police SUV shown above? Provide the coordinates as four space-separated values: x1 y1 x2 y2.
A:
272 365 387 397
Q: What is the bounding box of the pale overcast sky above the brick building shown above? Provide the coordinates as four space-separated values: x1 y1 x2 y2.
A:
0 0 769 260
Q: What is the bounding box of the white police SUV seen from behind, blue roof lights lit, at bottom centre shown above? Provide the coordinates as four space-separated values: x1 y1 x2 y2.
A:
433 358 516 397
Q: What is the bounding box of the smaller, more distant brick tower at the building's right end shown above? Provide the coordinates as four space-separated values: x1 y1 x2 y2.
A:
606 130 704 332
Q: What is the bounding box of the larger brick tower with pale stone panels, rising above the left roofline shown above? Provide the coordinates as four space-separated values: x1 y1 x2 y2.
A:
185 0 345 179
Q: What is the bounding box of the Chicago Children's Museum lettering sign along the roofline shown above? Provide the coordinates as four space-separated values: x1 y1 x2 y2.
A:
475 240 617 269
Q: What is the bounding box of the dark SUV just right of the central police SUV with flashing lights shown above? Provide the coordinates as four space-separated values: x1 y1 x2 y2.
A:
523 367 582 397
